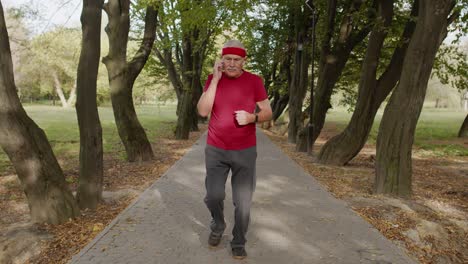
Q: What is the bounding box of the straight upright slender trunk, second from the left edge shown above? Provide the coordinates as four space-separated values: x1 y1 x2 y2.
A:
76 0 104 210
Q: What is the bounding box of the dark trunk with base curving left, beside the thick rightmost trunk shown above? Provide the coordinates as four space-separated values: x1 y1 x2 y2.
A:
317 1 398 165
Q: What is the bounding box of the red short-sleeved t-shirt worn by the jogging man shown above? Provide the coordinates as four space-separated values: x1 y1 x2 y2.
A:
203 71 268 150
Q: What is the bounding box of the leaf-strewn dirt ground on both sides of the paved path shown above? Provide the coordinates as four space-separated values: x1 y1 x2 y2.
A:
0 126 468 264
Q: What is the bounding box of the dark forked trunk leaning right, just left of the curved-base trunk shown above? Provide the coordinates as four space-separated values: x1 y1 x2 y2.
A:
312 0 374 142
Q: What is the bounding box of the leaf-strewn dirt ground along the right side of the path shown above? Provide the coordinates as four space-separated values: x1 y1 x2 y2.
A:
264 126 468 264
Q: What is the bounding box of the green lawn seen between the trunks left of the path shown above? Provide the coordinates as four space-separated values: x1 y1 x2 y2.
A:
0 105 176 175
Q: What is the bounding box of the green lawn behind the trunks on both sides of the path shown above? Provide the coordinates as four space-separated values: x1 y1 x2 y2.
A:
0 105 462 175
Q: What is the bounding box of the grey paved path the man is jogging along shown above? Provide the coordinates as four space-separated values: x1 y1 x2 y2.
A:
71 132 415 264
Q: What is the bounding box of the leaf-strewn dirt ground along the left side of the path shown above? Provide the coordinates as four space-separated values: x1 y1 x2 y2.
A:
0 125 206 264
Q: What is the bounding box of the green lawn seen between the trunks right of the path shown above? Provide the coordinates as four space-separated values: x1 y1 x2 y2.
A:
326 107 468 156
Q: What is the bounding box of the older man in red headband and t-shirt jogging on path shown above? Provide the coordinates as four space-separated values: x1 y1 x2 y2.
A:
197 40 272 259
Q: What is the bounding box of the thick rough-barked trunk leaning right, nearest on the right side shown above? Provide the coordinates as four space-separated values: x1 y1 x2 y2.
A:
374 0 455 197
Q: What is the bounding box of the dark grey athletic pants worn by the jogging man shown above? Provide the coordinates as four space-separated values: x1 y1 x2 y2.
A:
204 145 257 247
